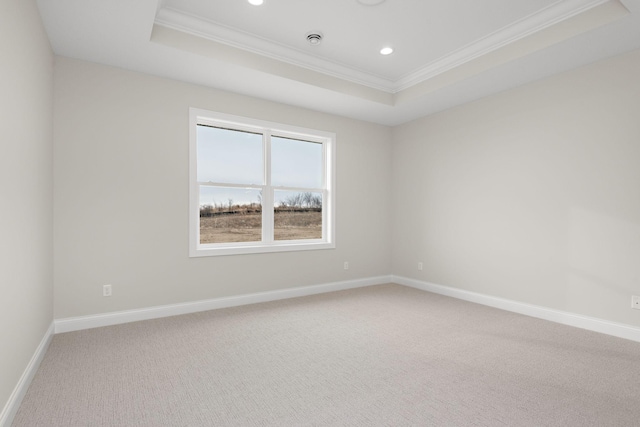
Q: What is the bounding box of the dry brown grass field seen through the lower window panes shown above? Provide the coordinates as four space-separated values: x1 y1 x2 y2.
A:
200 209 322 243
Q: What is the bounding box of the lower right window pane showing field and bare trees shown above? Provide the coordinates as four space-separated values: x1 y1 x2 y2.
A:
273 190 322 240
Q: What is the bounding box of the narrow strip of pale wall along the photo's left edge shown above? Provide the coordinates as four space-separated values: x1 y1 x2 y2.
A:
0 0 53 418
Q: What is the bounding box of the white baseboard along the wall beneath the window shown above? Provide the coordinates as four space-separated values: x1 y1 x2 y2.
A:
54 276 391 334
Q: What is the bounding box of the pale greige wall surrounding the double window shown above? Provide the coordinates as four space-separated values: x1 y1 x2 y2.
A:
54 58 391 318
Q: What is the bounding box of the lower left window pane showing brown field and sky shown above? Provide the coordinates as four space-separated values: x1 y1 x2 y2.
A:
200 186 262 244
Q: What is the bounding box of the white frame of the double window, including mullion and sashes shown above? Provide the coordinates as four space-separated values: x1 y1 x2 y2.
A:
189 108 336 257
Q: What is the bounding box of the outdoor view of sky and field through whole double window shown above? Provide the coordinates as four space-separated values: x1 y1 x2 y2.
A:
197 125 324 244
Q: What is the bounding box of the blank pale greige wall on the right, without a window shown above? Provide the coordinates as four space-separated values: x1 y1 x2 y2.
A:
392 51 640 326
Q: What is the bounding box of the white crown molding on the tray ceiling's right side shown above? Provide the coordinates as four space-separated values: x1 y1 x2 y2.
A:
394 0 620 92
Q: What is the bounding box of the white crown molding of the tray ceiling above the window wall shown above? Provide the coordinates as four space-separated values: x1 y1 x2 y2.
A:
155 8 395 93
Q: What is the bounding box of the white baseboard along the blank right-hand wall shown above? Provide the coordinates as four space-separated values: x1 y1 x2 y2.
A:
391 275 640 342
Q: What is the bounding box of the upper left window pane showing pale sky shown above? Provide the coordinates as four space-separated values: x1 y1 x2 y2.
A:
196 125 264 185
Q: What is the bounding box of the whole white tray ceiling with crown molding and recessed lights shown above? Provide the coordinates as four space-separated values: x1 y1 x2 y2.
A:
38 0 640 125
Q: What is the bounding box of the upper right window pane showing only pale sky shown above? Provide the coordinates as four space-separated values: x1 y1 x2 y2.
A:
271 137 324 188
